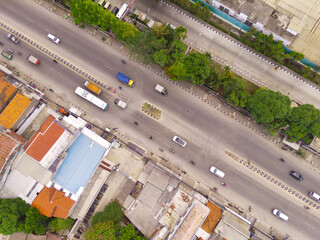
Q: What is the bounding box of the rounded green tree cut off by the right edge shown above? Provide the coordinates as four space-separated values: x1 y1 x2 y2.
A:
287 104 320 143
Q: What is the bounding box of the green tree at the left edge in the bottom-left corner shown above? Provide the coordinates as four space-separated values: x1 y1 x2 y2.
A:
0 198 30 235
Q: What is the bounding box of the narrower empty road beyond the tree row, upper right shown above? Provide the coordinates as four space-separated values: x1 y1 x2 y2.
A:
135 0 320 108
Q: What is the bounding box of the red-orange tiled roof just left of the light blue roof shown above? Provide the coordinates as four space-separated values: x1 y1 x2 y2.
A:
26 115 64 162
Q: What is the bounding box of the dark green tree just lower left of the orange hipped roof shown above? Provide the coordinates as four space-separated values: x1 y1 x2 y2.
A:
24 207 49 234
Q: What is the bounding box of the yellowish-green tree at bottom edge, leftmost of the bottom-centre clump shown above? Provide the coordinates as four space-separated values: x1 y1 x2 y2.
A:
84 221 118 240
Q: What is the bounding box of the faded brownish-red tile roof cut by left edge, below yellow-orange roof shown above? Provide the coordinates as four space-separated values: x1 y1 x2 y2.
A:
0 132 24 170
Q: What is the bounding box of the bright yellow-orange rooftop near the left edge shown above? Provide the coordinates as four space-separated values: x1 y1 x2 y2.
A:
0 93 31 129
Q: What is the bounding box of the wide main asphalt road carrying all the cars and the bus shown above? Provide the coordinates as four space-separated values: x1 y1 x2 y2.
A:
0 0 320 239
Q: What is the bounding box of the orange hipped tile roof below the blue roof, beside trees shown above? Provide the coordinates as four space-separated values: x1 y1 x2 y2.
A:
31 187 75 219
